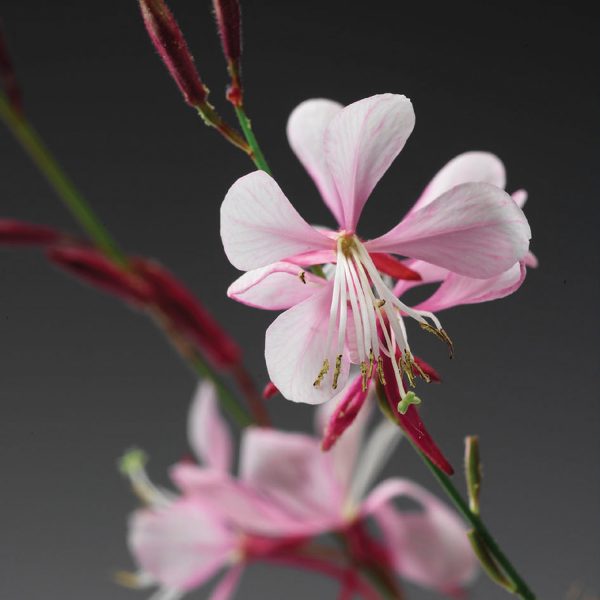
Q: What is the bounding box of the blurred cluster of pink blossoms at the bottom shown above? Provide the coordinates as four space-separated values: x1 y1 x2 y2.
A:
127 383 476 600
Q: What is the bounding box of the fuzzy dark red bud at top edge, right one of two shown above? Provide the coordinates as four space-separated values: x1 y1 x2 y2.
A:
213 0 242 106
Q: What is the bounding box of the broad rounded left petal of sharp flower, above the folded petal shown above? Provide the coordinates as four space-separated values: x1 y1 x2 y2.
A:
221 171 333 271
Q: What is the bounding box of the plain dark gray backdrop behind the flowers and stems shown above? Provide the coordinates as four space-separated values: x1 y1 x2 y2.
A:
0 0 600 600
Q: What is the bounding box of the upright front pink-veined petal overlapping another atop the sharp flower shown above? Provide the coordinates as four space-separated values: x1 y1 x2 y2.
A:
325 94 415 231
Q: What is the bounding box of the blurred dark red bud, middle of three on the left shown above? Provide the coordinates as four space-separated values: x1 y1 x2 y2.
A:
47 245 153 306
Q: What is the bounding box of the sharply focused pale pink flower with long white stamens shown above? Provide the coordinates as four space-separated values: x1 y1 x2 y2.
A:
221 94 530 412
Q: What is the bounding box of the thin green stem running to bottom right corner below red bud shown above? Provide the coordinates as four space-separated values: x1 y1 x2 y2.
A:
408 438 535 600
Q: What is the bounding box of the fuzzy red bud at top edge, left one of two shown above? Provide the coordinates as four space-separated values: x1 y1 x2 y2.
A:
139 0 208 108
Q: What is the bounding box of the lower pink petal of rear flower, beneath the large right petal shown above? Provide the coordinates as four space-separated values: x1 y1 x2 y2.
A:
415 261 526 312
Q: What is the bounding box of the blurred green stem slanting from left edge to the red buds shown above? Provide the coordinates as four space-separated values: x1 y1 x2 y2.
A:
0 94 127 266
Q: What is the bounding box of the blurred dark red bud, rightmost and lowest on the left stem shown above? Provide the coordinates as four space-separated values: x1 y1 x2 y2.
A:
132 259 241 368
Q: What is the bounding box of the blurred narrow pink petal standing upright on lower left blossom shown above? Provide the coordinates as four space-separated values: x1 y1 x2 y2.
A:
188 381 233 472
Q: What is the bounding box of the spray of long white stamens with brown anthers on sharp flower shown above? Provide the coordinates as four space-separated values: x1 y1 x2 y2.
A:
313 232 451 403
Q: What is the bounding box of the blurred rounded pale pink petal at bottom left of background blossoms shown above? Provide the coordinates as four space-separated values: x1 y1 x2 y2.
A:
128 500 237 590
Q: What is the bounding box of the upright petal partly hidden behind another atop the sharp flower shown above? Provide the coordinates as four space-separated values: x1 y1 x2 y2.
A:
287 98 344 226
